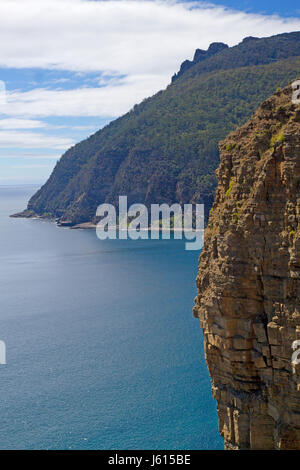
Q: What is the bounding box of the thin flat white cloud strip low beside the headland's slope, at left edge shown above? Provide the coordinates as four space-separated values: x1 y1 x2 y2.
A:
0 130 73 150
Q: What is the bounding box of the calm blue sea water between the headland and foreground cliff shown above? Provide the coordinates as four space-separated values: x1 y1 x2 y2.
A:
0 187 223 449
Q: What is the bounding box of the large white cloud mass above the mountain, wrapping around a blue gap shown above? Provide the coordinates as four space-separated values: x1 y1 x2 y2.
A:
0 0 300 117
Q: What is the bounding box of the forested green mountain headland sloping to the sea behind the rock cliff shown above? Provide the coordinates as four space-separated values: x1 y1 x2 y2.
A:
14 32 300 225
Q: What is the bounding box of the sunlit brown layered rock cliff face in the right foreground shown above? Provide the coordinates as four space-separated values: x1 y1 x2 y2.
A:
194 82 300 449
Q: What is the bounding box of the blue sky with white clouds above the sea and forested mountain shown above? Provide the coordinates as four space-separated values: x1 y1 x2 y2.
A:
0 0 300 185
